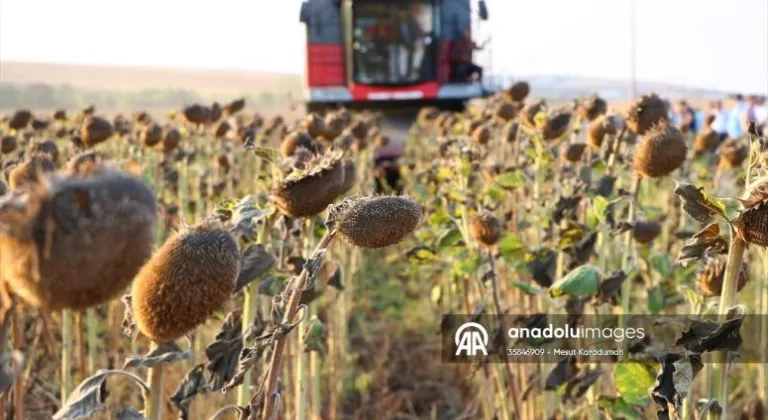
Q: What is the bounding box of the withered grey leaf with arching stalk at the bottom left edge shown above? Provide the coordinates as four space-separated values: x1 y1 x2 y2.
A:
53 370 149 420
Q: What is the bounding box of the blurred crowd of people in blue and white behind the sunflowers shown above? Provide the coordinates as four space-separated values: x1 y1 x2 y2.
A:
670 94 768 140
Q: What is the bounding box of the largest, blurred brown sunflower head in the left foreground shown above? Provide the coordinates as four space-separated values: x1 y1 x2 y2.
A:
0 168 157 310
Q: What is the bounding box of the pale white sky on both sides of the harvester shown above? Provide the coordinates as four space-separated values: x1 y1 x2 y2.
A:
0 0 768 94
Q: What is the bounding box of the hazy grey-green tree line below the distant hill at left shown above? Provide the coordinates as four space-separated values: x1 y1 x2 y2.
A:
0 83 288 109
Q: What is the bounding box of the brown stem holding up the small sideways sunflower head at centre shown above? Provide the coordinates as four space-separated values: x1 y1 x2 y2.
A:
260 230 336 420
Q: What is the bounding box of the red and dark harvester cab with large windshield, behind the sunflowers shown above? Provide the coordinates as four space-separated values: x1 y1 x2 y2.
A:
300 0 496 112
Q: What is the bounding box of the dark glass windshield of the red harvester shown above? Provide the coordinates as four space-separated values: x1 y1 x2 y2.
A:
352 0 439 85
